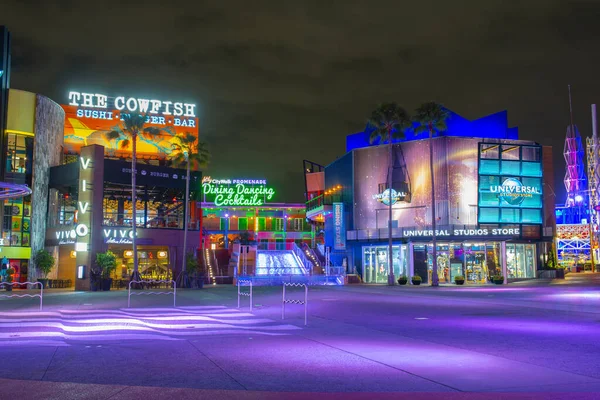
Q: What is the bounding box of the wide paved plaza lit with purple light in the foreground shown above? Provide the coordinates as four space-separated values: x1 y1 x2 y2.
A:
0 274 600 399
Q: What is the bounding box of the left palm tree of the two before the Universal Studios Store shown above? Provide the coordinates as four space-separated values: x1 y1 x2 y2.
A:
369 103 411 285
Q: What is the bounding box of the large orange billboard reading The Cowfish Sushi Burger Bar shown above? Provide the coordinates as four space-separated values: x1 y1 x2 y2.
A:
62 92 198 159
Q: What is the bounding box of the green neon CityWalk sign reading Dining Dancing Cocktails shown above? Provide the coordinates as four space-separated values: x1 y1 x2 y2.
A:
202 177 275 207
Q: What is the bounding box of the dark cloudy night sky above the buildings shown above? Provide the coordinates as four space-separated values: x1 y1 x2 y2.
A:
0 0 600 203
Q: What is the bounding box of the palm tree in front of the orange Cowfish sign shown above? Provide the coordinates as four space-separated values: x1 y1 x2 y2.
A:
106 113 161 281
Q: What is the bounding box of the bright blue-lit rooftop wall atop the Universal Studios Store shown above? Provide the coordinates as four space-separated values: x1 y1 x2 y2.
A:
346 110 519 151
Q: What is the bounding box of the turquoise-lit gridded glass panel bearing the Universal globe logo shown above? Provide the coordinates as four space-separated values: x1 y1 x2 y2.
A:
477 143 543 224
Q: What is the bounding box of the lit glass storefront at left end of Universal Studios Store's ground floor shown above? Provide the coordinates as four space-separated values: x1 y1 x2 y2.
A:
362 244 409 283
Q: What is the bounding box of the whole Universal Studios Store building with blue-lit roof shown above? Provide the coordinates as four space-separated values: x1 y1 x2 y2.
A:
325 112 555 284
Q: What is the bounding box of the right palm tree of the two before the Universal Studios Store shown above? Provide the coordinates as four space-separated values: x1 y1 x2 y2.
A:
414 101 450 286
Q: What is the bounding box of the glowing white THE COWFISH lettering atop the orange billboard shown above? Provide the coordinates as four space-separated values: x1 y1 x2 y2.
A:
69 92 196 117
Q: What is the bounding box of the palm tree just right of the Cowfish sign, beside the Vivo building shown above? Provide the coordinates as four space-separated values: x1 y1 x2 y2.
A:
171 132 210 287
